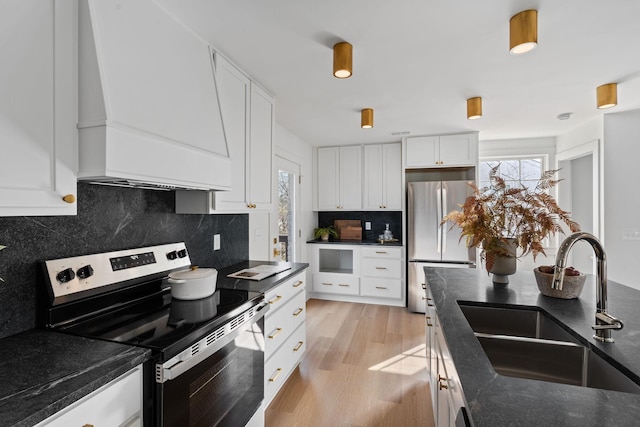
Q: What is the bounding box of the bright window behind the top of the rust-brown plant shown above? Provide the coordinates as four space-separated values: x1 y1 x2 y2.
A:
478 156 544 190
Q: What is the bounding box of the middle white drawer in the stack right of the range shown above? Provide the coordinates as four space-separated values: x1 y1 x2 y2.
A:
264 292 306 360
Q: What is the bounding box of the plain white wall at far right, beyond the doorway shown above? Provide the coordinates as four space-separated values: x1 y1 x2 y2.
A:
603 110 640 289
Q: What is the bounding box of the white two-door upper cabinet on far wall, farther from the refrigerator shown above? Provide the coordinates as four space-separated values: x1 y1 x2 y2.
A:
316 145 362 211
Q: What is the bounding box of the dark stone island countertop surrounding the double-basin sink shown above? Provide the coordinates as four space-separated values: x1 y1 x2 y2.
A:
424 267 640 427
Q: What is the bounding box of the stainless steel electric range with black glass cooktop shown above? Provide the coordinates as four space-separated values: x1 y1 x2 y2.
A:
43 243 269 427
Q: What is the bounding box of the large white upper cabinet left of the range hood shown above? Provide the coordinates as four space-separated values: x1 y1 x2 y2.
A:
0 0 78 216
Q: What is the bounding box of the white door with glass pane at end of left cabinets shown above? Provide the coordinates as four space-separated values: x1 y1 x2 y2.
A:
269 155 301 262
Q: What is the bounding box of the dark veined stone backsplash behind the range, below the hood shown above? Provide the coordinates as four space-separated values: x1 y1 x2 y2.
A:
0 183 249 338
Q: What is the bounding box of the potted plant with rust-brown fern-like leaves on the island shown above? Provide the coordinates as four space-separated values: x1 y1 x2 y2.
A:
442 164 580 283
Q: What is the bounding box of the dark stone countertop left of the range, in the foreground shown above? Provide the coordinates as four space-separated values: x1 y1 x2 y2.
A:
0 329 150 427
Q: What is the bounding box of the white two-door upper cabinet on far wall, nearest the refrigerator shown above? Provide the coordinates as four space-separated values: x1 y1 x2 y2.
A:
363 143 402 210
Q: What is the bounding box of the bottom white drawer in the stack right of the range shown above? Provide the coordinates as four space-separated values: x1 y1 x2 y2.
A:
264 323 307 407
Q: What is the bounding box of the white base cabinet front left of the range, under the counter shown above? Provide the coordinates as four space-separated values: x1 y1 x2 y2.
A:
35 366 142 427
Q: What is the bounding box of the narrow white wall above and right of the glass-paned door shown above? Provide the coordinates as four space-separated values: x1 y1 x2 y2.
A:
274 123 316 262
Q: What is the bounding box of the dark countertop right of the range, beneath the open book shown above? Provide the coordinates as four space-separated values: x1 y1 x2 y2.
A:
216 261 309 293
